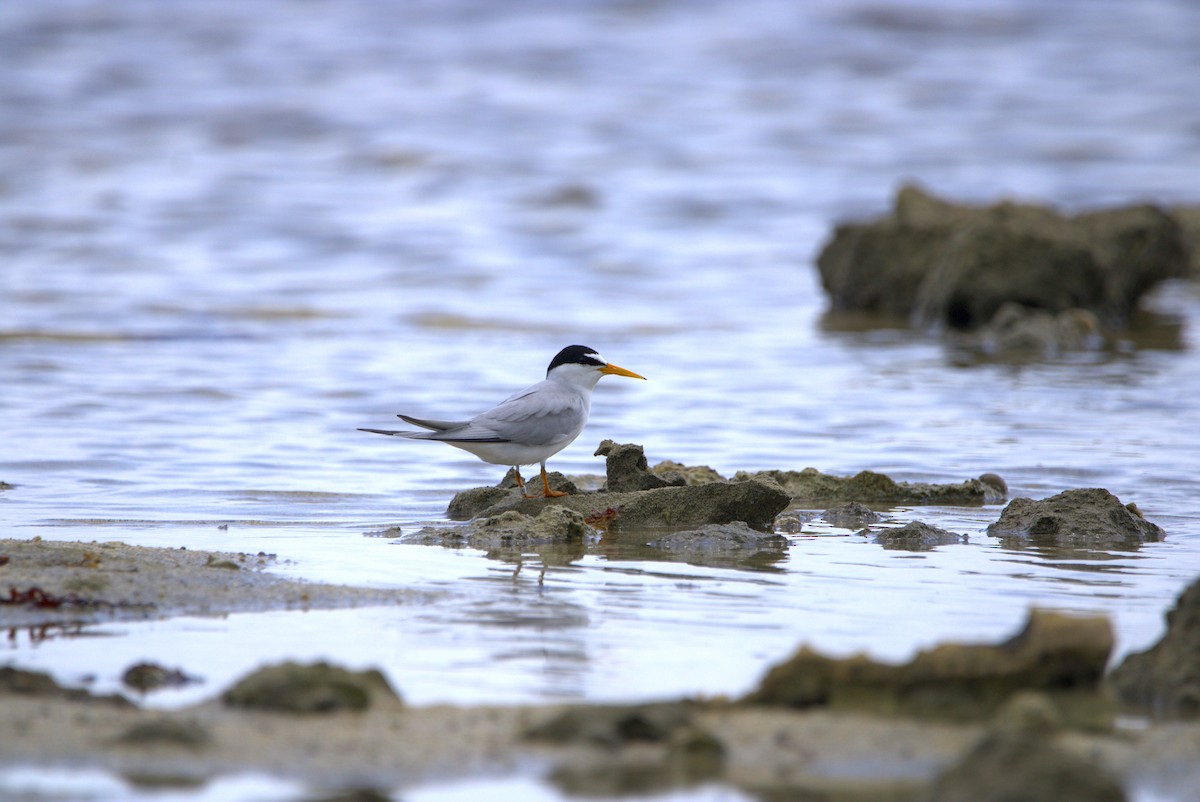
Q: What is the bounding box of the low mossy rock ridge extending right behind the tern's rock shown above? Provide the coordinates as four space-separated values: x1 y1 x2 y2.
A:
734 468 1004 507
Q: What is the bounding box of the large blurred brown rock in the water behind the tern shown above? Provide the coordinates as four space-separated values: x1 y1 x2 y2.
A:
817 186 1188 330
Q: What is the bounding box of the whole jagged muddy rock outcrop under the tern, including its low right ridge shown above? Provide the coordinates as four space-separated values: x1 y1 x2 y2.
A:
441 441 1008 547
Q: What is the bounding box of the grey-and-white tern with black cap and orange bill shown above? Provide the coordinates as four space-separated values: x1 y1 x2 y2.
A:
359 346 646 498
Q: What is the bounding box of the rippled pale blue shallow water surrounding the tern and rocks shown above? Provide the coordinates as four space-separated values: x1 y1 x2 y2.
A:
0 0 1200 798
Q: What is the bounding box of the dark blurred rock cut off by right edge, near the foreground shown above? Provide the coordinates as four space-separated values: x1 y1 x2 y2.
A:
1109 580 1200 719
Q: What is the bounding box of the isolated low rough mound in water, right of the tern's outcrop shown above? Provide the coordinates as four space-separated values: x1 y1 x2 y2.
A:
988 487 1166 551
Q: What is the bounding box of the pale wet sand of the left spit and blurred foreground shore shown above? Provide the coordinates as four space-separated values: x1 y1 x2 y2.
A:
0 540 1200 800
